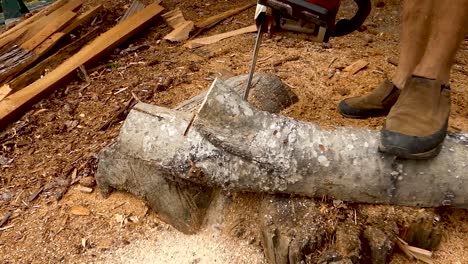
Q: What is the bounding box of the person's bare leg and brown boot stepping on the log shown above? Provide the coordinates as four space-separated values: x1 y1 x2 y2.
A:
380 0 468 159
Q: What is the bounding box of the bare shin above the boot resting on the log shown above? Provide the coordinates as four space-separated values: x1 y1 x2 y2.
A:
411 0 468 83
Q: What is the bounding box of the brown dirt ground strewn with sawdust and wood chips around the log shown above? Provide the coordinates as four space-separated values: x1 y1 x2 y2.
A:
0 0 468 263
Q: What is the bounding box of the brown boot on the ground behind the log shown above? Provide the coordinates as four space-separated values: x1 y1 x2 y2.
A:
338 80 400 118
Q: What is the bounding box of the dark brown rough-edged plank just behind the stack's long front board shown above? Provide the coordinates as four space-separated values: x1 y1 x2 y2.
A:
8 28 102 92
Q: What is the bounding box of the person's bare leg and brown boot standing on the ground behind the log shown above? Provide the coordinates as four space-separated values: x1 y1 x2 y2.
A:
338 0 434 118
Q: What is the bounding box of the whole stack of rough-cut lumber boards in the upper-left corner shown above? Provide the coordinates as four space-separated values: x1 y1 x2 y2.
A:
0 0 163 128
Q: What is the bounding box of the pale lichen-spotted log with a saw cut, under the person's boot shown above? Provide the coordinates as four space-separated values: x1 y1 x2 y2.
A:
97 77 468 208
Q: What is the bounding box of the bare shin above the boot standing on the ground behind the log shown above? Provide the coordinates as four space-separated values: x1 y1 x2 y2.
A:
392 0 434 89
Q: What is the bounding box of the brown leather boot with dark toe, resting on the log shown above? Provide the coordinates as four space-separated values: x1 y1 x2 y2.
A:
379 76 450 159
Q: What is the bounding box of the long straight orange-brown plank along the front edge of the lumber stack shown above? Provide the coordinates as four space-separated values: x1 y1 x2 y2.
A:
0 4 164 127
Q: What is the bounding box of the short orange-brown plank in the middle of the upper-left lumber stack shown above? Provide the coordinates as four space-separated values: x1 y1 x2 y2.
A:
21 11 76 51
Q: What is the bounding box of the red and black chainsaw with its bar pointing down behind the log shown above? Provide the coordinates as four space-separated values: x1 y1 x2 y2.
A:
244 0 371 99
